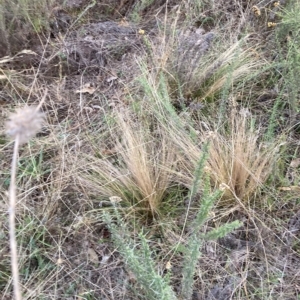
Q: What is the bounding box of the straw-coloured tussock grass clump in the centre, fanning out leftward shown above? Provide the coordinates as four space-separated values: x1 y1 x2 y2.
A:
80 114 176 216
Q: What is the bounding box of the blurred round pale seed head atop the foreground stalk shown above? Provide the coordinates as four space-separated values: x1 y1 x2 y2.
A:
6 106 44 144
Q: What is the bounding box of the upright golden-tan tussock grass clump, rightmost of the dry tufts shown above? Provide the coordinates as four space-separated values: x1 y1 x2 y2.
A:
205 112 278 203
